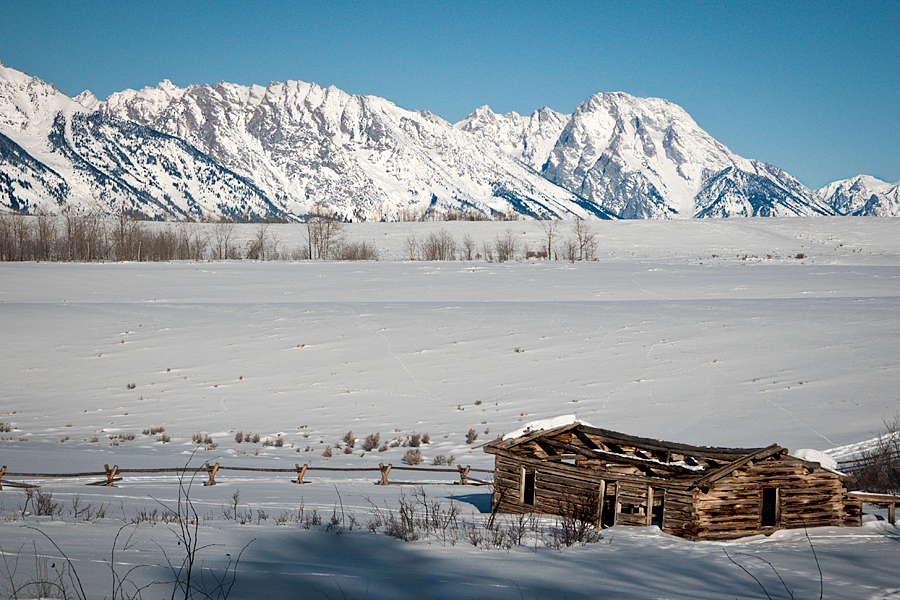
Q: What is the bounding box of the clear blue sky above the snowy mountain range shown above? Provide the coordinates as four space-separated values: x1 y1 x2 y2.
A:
0 0 900 188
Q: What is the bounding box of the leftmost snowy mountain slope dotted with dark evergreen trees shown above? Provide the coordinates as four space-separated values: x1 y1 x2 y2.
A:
0 65 277 219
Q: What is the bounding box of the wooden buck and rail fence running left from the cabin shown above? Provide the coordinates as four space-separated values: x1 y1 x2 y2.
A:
0 463 494 490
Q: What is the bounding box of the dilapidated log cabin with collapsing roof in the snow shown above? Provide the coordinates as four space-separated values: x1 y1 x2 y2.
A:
484 422 862 540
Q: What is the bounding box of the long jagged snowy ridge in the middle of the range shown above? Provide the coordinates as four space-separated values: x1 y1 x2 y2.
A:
100 81 601 220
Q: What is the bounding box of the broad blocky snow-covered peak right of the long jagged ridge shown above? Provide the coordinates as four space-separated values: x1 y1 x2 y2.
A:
456 93 834 219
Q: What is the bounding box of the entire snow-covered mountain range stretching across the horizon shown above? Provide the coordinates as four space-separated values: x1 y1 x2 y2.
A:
0 65 900 220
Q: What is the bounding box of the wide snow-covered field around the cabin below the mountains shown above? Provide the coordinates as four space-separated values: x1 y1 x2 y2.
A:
0 218 900 599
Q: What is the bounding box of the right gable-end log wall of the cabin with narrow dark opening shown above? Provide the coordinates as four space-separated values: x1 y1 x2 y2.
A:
696 457 845 539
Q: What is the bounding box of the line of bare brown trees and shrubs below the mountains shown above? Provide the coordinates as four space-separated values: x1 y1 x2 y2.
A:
0 209 598 262
